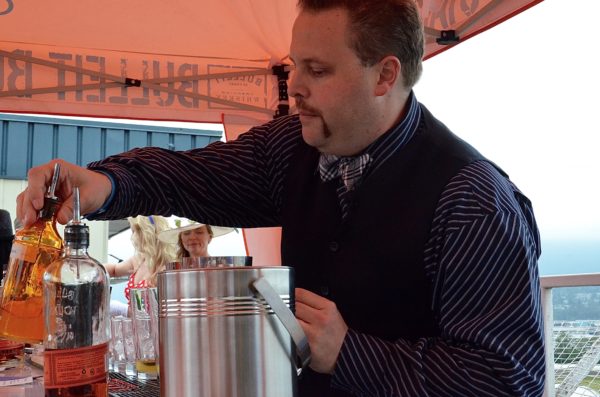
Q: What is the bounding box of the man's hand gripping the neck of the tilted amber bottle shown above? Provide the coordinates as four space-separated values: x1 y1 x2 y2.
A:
17 160 112 227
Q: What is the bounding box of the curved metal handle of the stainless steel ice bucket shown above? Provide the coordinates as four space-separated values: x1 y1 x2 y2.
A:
251 277 310 375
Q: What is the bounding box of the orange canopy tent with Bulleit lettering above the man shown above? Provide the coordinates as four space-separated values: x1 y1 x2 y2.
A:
0 0 541 264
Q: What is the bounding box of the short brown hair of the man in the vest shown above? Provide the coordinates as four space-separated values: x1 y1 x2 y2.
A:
298 0 424 88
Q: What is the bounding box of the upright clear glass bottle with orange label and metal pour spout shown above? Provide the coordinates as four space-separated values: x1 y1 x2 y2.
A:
44 188 110 397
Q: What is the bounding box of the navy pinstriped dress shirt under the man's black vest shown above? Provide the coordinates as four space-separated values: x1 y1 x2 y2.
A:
89 95 544 397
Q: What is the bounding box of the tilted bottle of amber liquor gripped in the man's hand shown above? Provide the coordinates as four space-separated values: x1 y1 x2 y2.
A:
0 164 63 343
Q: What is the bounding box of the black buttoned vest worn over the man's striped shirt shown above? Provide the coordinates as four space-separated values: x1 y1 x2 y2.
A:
282 106 496 397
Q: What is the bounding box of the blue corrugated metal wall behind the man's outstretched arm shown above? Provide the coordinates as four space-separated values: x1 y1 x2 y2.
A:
0 114 222 179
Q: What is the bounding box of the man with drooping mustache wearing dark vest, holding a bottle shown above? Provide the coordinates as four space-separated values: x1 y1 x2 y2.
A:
18 0 544 397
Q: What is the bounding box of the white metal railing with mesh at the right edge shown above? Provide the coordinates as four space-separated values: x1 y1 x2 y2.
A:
540 273 600 397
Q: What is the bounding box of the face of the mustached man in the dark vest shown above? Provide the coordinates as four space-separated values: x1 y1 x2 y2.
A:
289 8 378 156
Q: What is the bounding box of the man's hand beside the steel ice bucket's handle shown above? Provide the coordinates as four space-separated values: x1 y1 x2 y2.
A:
296 288 348 374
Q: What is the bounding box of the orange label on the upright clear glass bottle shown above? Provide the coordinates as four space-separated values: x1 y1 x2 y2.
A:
44 343 108 389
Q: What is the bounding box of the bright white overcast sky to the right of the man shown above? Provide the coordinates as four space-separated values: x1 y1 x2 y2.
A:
415 0 600 241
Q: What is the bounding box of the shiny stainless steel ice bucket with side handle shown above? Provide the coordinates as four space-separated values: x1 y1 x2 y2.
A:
158 266 310 397
